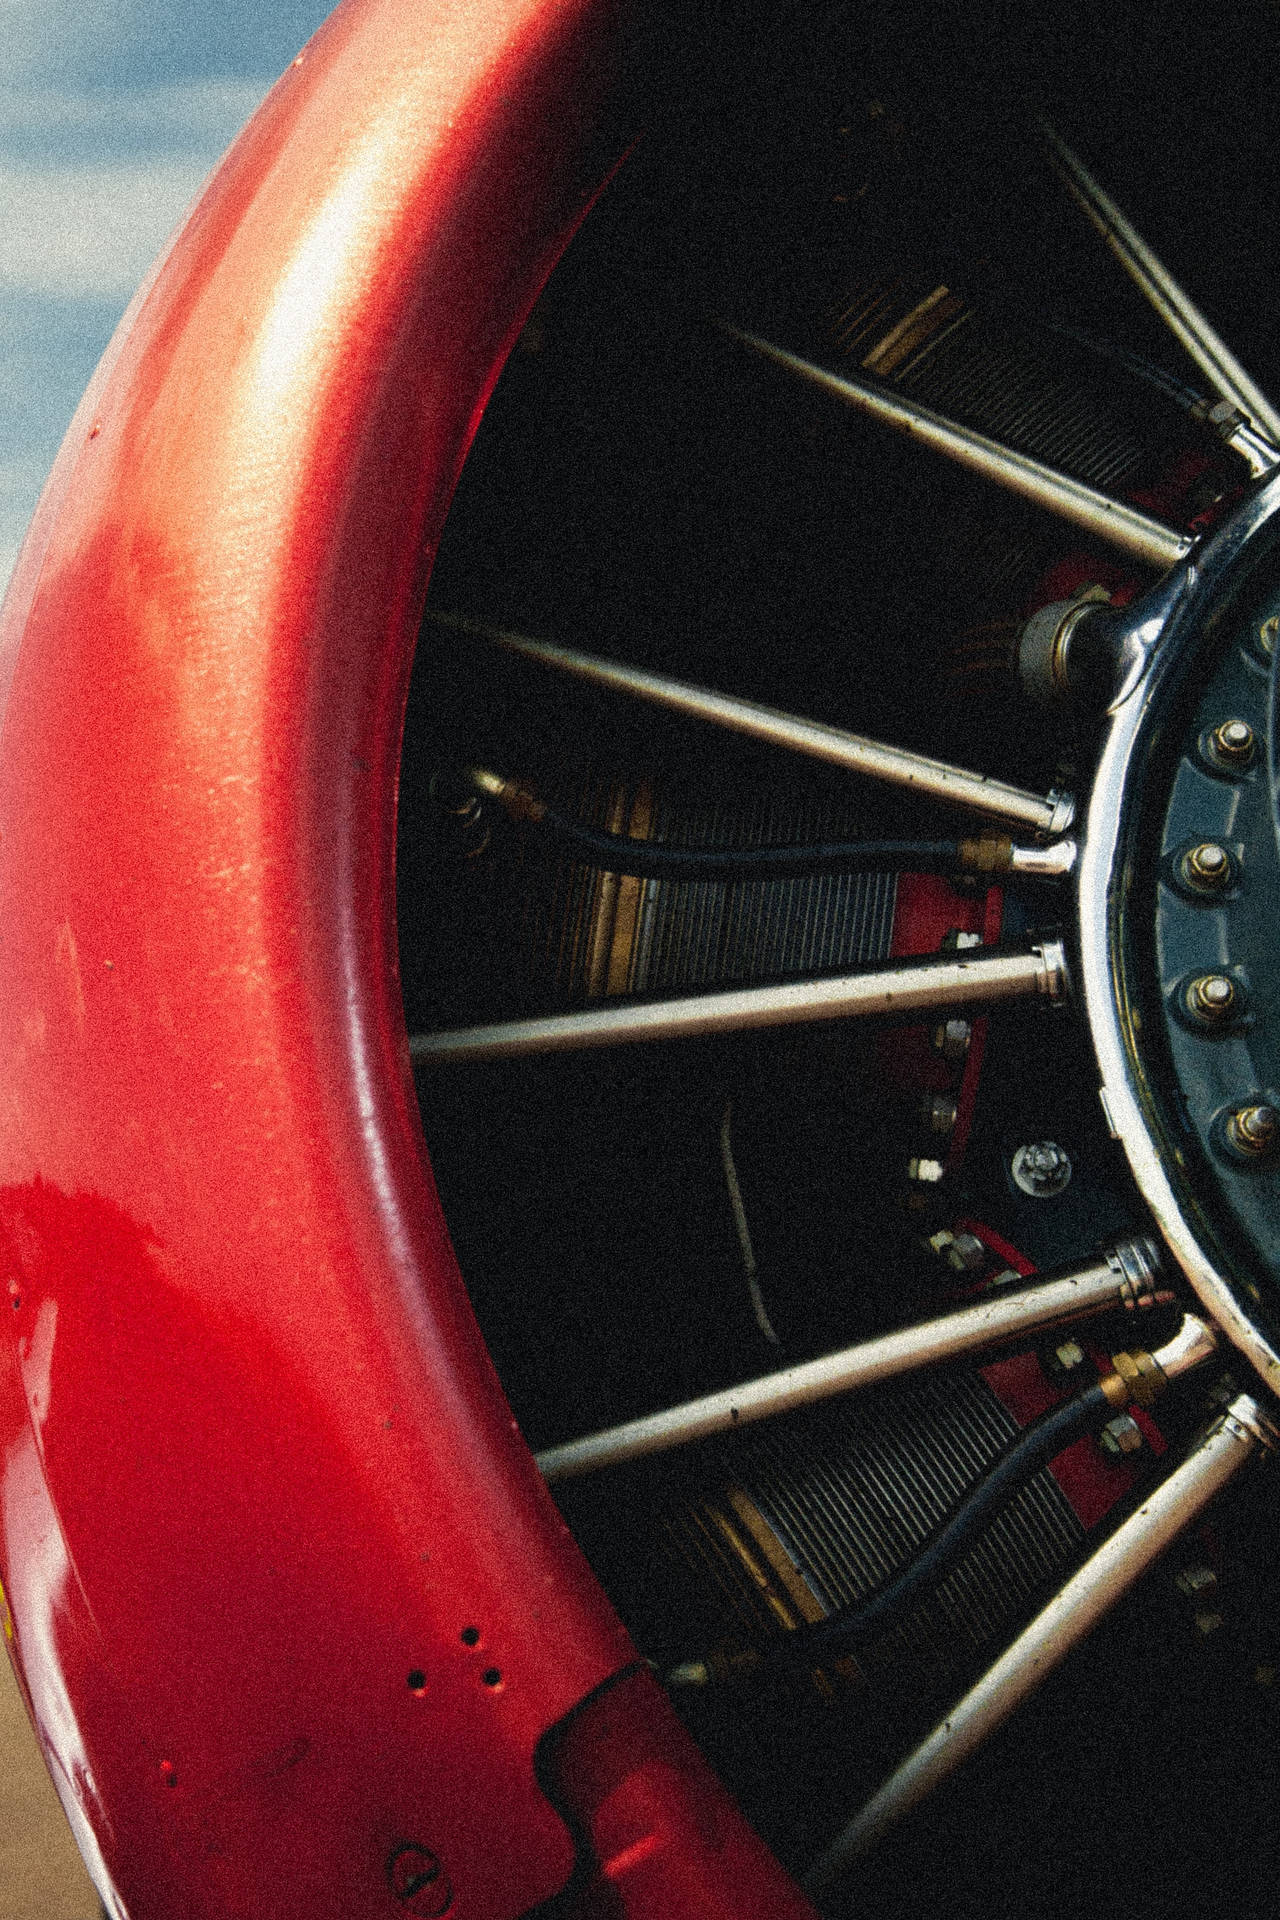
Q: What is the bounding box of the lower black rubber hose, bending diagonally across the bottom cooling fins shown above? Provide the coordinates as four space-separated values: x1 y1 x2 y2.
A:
756 1386 1115 1670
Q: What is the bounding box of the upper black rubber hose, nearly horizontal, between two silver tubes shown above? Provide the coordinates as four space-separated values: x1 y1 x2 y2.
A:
537 806 961 879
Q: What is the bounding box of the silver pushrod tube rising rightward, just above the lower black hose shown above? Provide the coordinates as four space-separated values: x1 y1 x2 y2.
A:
537 1240 1157 1480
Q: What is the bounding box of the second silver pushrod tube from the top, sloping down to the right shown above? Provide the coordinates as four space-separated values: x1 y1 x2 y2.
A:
725 326 1194 572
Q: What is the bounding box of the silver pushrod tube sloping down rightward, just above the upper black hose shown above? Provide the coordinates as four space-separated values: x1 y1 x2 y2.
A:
428 611 1075 837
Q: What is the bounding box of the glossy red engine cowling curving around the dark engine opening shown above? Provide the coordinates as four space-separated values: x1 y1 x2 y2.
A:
0 0 821 1920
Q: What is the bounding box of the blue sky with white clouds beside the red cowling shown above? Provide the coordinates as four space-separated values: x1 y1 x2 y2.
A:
0 0 328 589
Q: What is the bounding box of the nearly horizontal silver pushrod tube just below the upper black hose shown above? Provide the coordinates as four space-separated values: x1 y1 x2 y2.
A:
409 939 1067 1066
